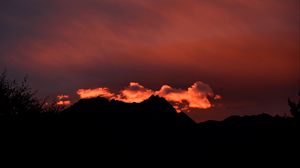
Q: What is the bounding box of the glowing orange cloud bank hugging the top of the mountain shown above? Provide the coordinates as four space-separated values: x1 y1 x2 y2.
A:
77 81 221 112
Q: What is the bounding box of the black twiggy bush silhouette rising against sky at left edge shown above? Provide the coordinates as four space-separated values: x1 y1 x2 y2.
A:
0 71 63 119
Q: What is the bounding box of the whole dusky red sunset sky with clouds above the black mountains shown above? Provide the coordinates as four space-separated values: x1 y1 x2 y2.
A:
0 0 300 122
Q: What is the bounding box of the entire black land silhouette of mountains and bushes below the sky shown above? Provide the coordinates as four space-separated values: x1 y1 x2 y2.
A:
0 73 300 161
